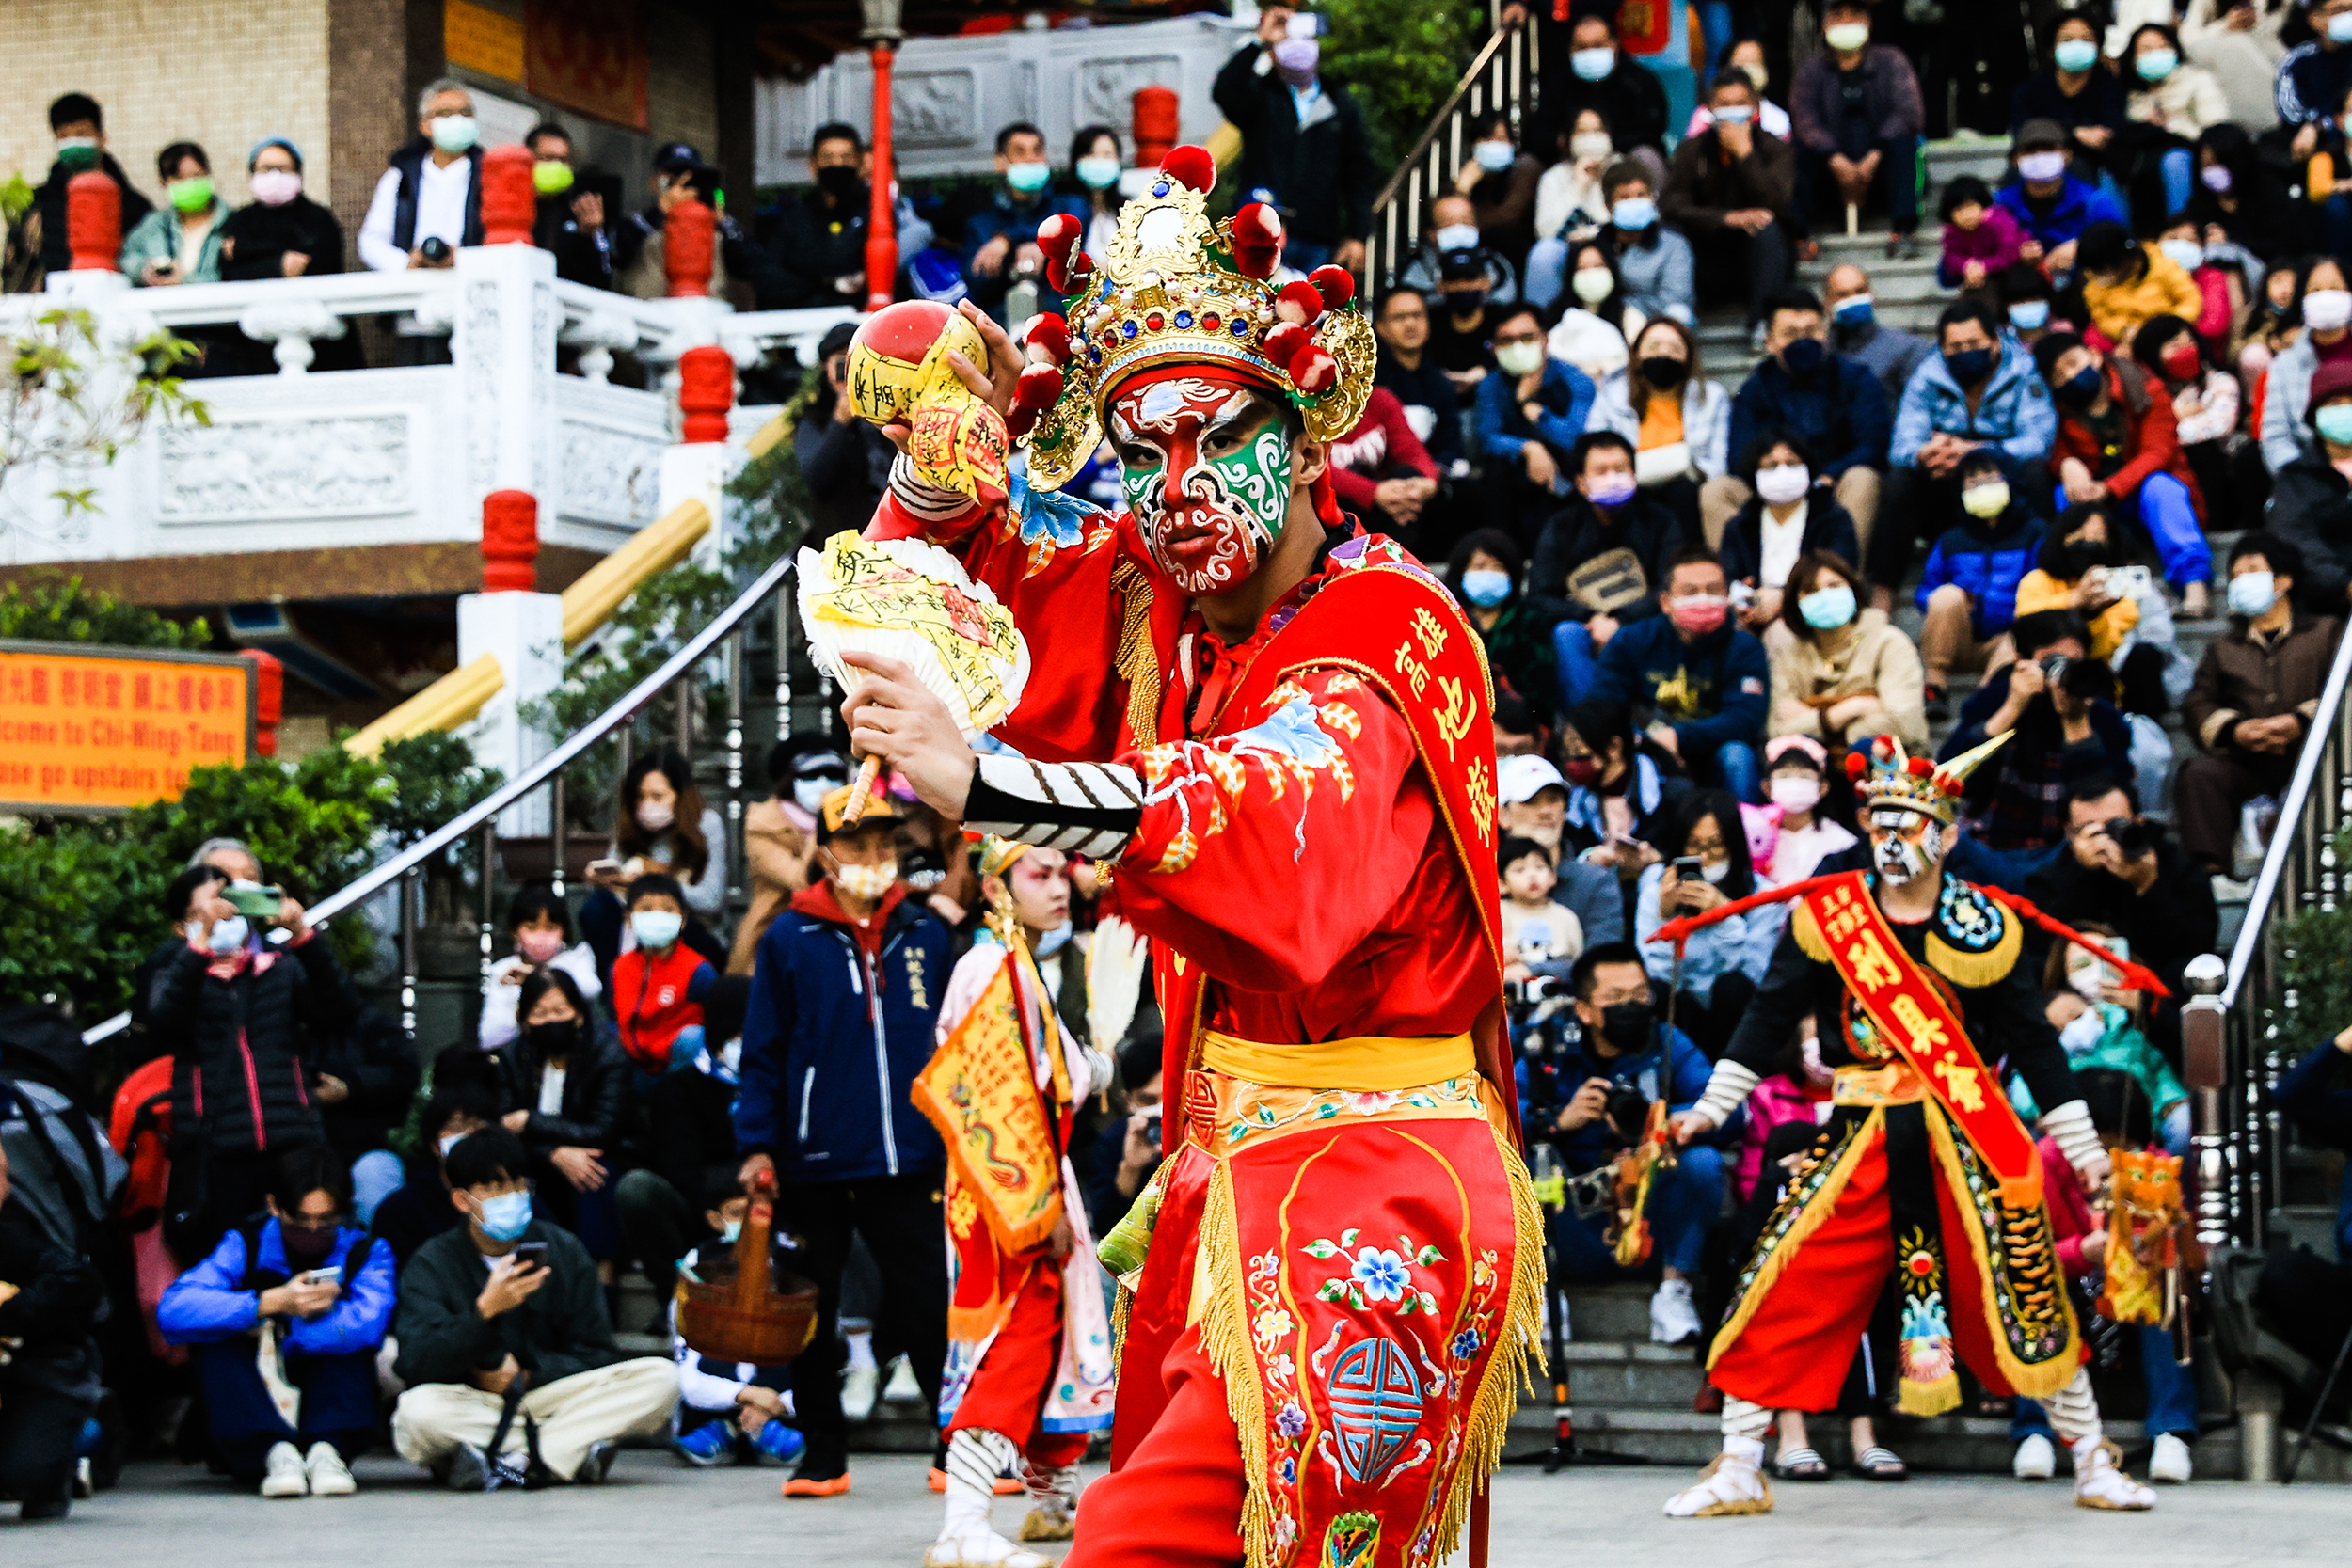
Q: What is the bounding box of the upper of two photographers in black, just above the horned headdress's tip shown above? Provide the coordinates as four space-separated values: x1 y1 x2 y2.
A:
1936 609 2131 860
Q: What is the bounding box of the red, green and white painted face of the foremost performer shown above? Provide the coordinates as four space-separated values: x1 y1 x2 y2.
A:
1110 373 1292 594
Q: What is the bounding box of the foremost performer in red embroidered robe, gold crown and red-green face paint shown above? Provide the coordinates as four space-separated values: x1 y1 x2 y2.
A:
845 148 1541 1568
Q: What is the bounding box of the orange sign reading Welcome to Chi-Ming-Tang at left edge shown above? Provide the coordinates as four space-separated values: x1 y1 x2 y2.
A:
0 641 254 811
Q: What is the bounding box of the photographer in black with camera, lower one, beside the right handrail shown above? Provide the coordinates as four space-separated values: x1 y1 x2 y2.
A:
2026 773 2220 1006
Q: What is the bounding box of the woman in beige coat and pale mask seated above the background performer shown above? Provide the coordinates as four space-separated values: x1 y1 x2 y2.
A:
1764 550 1927 752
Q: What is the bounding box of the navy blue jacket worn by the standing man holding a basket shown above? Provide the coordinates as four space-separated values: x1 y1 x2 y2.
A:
734 884 953 1182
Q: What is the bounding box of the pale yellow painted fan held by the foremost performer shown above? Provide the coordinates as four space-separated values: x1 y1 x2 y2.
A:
800 533 1030 823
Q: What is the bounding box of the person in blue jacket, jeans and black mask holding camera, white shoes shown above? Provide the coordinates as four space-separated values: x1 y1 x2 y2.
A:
1529 942 1743 1345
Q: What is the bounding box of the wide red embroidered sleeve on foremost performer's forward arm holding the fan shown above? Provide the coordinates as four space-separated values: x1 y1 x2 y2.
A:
1118 670 1435 992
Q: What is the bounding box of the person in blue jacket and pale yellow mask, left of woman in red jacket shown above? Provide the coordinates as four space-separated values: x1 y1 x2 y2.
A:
1917 451 2044 717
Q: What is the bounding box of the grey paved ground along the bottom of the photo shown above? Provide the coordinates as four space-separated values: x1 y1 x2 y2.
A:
13 1450 2352 1568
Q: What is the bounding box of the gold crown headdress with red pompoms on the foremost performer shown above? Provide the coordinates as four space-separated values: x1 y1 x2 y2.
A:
1007 146 1376 489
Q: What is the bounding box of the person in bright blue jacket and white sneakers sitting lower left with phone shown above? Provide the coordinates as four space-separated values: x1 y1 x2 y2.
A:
155 1148 393 1497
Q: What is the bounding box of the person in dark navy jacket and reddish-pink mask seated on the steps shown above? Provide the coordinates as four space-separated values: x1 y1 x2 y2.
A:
1560 550 1769 801
